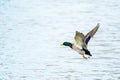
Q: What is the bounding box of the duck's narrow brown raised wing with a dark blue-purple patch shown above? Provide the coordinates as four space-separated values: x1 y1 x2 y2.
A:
85 24 100 44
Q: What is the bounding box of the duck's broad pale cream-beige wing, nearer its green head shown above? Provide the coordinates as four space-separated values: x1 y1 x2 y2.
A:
74 31 86 47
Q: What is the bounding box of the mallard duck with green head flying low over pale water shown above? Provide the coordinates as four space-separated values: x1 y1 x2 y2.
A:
61 24 99 59
